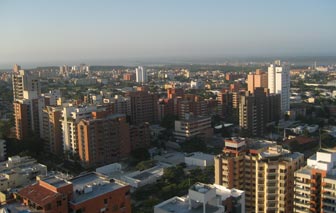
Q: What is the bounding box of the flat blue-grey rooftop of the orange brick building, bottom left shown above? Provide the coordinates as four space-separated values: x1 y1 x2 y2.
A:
70 172 126 204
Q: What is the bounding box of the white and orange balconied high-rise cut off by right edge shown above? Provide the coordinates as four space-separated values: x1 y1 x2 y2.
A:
294 149 336 213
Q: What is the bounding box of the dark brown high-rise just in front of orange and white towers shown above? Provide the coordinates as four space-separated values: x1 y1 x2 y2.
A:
239 87 280 136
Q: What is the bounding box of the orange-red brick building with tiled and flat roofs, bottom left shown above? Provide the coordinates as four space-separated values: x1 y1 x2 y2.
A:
17 172 131 213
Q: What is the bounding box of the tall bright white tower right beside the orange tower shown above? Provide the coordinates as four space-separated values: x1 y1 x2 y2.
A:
268 61 290 112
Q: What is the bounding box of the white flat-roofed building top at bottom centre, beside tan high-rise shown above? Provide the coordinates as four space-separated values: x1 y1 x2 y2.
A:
154 183 245 213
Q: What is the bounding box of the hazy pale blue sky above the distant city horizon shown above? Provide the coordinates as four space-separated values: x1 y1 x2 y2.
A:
0 0 336 68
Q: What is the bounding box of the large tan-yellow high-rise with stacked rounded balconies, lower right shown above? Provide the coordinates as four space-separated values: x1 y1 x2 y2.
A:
215 138 304 213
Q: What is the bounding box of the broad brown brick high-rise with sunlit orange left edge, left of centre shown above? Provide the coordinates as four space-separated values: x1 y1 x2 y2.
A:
77 111 131 166
